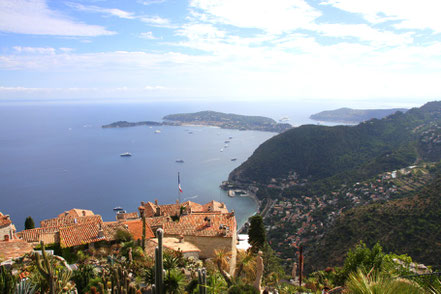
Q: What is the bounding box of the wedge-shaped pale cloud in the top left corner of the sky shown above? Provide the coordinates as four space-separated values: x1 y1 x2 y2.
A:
0 0 115 37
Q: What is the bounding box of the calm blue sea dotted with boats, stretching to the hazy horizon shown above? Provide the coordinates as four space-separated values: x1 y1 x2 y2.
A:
0 102 412 230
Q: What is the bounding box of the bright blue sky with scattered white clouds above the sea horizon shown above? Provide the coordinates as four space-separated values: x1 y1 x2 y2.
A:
0 0 441 103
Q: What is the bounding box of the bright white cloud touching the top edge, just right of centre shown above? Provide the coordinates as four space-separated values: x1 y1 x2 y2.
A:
190 0 321 33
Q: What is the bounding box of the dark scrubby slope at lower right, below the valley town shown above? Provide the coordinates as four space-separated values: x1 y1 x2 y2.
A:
307 174 441 268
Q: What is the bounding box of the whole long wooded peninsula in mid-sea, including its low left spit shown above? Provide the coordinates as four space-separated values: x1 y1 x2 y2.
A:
102 111 292 133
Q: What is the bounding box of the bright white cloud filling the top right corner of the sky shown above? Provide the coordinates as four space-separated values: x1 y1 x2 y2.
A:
322 0 441 32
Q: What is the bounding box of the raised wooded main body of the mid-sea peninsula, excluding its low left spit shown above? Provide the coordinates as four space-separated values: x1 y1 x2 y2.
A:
163 111 291 132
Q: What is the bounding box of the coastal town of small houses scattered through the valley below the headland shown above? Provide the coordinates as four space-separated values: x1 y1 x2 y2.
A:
221 164 432 267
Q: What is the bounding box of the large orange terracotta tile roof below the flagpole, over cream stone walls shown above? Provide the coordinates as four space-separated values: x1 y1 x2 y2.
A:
146 213 236 237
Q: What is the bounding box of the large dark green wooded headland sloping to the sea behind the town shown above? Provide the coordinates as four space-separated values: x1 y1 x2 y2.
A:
229 102 441 184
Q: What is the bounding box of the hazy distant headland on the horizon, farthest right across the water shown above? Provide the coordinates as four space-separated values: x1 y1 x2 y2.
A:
309 107 407 124
